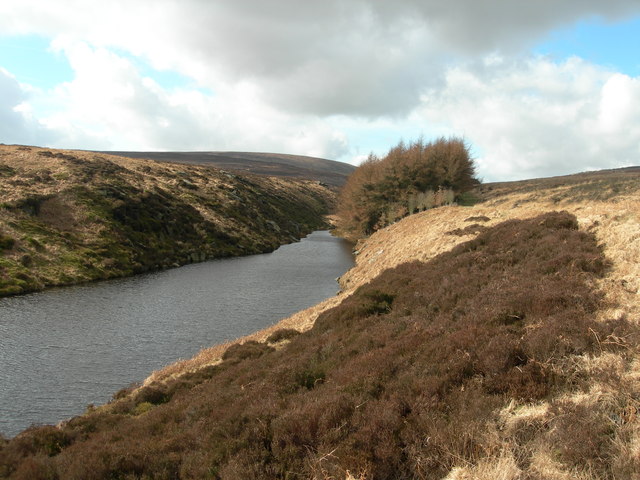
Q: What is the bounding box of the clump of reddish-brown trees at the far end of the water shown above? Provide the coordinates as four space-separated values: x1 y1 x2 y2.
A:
338 138 479 238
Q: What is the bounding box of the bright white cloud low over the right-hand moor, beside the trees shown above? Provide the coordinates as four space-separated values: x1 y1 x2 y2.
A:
418 57 640 180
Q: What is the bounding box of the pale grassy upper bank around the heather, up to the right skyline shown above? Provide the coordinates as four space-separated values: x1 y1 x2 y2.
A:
148 167 640 382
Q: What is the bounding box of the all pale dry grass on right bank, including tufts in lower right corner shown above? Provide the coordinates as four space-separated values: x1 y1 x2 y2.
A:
140 167 640 480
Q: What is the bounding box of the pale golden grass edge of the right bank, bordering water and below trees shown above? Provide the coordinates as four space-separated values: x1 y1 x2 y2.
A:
142 188 640 386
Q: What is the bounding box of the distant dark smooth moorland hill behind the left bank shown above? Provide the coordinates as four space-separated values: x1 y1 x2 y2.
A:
101 151 355 187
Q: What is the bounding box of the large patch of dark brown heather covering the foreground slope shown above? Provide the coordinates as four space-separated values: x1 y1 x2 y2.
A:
0 212 640 480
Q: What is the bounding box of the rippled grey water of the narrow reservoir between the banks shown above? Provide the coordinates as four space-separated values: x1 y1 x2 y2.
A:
0 232 353 436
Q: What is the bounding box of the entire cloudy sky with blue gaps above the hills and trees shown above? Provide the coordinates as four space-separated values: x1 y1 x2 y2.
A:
0 0 640 181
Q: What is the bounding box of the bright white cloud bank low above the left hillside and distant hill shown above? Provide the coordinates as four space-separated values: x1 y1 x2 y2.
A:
36 41 345 158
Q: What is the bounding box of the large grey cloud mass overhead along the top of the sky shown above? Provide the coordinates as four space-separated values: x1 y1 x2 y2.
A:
5 0 639 116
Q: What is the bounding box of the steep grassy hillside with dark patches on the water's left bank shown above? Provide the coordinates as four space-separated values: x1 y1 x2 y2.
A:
0 145 335 296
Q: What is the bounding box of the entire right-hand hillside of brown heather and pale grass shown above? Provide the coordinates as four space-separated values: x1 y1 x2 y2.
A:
0 166 640 480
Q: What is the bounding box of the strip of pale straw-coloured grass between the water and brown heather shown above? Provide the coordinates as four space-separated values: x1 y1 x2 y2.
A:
151 169 640 386
